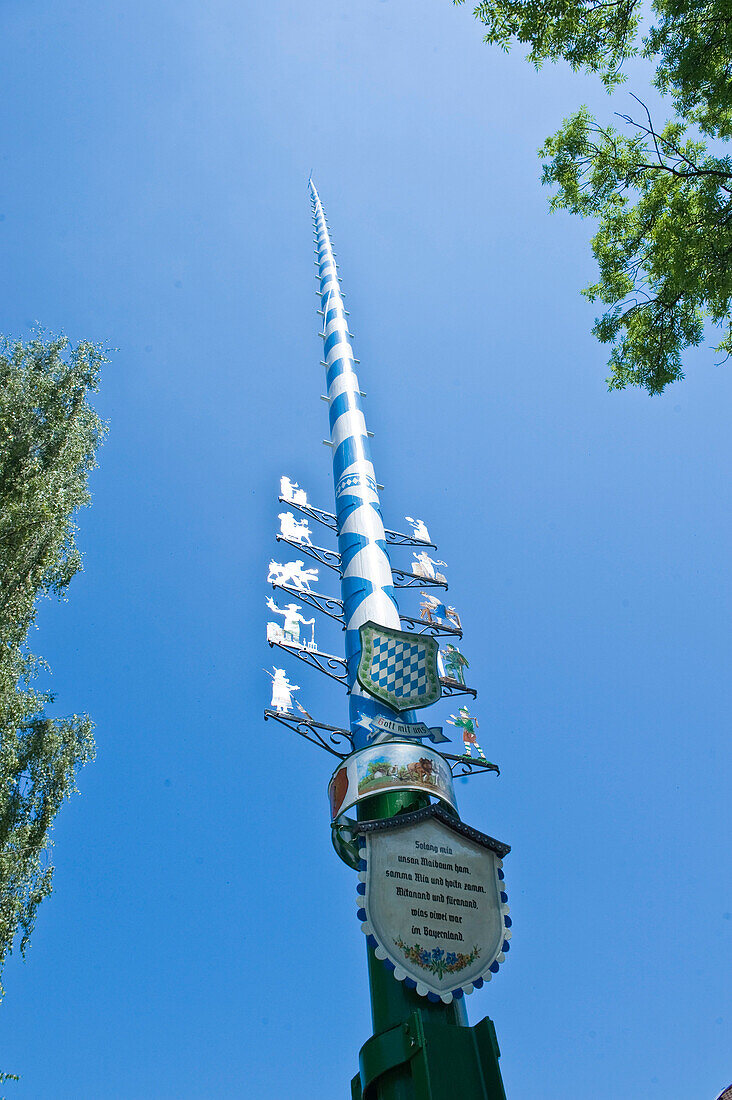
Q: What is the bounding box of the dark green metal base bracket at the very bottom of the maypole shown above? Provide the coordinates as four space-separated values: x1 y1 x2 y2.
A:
351 1009 505 1100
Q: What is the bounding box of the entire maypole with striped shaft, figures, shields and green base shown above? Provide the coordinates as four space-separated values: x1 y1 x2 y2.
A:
265 180 511 1100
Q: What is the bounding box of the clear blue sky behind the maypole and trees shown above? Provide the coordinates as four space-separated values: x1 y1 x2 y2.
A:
0 0 732 1100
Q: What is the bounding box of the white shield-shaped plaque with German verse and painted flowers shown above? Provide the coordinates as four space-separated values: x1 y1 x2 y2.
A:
357 806 511 1004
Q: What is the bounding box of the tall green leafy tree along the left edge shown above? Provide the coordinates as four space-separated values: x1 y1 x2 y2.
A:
0 336 106 994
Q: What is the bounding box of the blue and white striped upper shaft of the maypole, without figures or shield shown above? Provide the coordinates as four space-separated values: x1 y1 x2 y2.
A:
309 179 415 749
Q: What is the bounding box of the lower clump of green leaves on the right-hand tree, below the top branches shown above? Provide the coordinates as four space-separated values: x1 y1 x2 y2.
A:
542 109 732 394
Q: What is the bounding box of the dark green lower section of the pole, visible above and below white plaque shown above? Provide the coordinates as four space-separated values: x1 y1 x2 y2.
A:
351 791 505 1100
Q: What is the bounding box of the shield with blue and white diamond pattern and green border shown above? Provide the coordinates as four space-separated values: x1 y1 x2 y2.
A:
356 623 443 711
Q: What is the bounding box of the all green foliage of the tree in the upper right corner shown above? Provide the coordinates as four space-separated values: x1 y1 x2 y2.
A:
455 0 732 394
